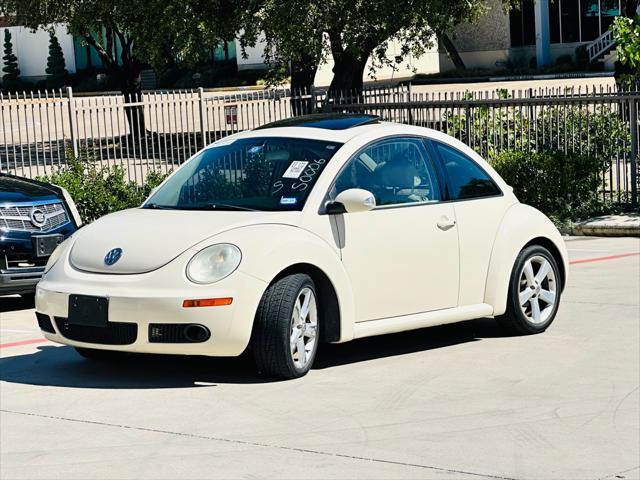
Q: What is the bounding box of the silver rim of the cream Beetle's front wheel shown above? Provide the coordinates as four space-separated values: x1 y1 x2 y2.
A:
290 287 318 368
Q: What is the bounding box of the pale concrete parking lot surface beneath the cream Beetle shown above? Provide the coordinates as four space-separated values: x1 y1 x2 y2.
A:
0 237 640 479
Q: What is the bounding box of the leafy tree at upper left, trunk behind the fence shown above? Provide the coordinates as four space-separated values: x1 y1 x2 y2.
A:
0 0 241 133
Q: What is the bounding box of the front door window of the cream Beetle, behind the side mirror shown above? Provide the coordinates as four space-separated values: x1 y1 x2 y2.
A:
333 138 441 205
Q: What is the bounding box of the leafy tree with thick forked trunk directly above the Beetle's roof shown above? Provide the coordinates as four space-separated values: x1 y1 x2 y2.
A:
243 0 500 91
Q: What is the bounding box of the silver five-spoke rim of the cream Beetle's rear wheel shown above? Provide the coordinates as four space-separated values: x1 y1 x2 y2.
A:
518 255 557 324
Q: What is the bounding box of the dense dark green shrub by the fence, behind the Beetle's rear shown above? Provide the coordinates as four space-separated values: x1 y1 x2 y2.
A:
490 150 611 223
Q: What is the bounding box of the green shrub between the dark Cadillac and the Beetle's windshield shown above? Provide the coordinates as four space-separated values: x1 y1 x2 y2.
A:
40 152 167 223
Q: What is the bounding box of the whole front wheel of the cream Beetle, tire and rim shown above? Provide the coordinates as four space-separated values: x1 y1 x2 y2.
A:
251 273 319 379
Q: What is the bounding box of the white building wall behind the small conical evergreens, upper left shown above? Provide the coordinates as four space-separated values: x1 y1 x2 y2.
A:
0 24 76 79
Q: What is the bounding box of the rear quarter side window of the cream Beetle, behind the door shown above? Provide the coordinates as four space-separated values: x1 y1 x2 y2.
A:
433 141 501 200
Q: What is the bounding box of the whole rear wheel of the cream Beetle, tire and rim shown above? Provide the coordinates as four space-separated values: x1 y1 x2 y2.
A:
498 245 562 335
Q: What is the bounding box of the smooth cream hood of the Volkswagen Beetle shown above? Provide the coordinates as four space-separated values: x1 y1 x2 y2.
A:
70 208 299 274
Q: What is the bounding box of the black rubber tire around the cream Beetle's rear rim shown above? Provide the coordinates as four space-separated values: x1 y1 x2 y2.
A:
496 245 562 335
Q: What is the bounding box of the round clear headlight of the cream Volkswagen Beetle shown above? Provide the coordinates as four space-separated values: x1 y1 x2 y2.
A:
187 243 242 283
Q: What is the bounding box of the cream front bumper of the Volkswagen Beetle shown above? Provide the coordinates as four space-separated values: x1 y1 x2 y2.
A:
36 258 267 356
